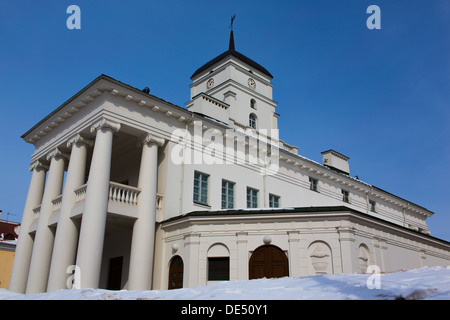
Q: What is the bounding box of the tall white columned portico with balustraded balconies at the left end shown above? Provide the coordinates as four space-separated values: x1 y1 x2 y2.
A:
11 107 166 294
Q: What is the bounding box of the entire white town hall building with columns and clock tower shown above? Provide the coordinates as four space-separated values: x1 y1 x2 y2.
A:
10 31 450 293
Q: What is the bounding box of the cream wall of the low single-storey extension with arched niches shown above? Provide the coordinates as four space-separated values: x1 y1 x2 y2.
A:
154 209 449 289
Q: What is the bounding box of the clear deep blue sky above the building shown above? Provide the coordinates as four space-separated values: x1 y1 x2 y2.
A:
0 0 450 241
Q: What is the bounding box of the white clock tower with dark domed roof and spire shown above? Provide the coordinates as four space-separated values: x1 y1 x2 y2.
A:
186 30 278 132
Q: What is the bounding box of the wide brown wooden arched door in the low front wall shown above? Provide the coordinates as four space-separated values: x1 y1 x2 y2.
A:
249 245 289 279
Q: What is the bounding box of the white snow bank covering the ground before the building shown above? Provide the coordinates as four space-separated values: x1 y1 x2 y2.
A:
0 266 450 300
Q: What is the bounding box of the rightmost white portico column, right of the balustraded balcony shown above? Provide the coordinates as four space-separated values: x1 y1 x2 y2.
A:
128 134 165 290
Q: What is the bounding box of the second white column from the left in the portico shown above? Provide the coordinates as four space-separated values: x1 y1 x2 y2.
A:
26 149 67 294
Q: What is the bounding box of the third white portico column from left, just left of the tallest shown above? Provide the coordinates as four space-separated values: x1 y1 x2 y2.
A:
47 134 93 291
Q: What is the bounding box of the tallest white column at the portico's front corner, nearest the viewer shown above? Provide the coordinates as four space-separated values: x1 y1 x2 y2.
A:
76 119 120 288
